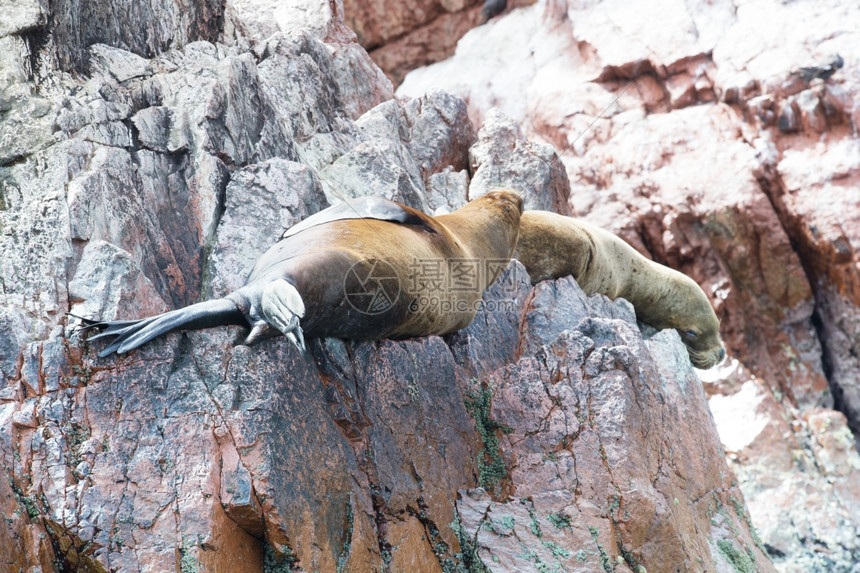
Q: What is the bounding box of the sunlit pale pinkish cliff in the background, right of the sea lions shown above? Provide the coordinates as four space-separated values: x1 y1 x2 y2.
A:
398 0 860 571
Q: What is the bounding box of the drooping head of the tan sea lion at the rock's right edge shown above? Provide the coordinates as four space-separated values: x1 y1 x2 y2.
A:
667 273 726 369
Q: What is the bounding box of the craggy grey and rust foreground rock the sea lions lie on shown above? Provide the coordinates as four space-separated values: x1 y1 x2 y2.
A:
0 0 780 573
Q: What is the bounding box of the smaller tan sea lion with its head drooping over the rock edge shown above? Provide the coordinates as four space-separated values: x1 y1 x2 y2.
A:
514 211 725 368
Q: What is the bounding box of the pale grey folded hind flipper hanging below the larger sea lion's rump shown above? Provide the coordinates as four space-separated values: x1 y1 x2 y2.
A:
245 279 307 352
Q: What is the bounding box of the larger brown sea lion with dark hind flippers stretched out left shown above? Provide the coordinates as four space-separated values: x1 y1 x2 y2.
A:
87 191 523 357
